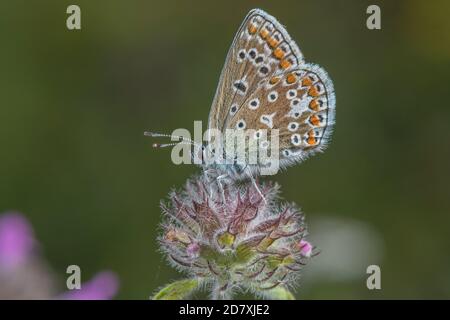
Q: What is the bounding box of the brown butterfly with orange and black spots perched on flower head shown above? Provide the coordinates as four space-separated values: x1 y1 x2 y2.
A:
146 9 336 185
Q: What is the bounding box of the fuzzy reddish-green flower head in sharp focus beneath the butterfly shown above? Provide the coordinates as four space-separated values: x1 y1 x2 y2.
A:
154 176 313 299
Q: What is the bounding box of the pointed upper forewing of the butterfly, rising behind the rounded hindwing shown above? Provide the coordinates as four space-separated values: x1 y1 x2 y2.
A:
208 9 303 131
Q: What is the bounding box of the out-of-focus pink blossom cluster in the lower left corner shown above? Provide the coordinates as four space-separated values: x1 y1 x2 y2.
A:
0 213 119 300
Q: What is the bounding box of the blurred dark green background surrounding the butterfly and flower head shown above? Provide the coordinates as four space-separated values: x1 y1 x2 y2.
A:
0 0 450 299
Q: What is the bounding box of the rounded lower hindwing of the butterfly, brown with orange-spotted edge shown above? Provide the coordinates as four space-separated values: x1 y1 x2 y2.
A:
227 63 335 167
